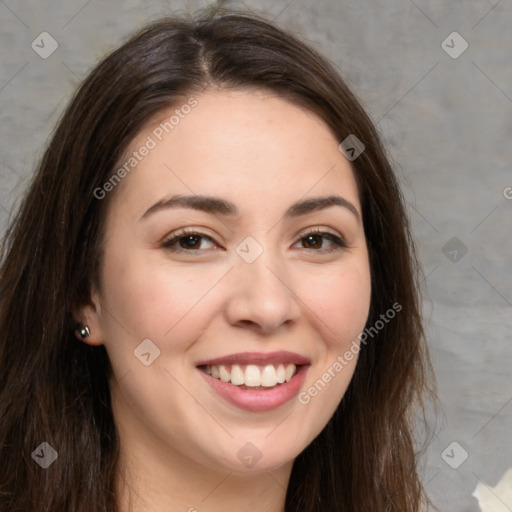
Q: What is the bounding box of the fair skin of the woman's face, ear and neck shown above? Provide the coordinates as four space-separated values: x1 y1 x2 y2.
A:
79 90 370 512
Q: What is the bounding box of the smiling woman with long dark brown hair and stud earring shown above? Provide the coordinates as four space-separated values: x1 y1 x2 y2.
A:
0 9 440 512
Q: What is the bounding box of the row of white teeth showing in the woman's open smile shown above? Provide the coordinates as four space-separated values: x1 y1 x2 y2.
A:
198 363 302 391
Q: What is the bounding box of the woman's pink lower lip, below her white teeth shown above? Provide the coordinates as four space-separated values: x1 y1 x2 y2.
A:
198 365 309 412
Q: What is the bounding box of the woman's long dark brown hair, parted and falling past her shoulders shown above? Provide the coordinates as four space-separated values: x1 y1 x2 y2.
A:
0 12 435 512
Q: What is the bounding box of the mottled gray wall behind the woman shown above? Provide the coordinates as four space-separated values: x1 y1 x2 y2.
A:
0 0 512 512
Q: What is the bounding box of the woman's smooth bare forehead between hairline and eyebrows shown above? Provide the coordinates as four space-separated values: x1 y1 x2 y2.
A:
107 90 358 220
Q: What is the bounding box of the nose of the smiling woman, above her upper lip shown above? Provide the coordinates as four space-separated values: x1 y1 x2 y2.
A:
225 251 300 334
